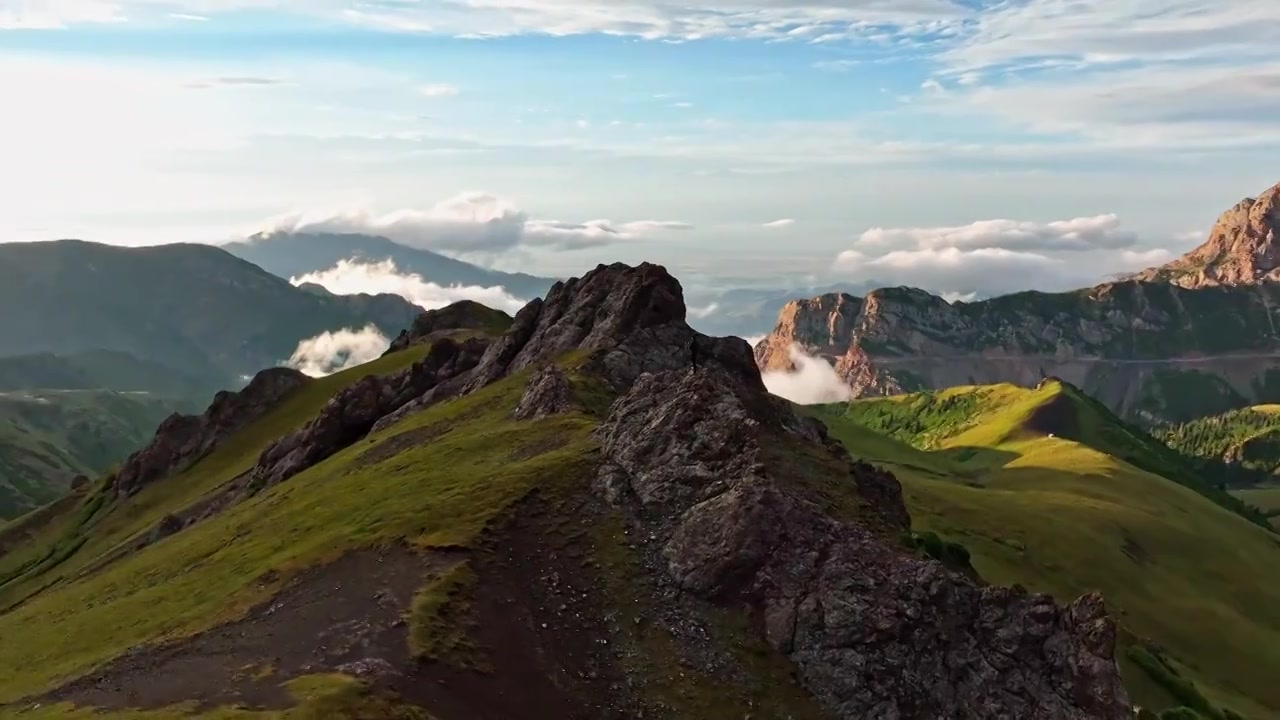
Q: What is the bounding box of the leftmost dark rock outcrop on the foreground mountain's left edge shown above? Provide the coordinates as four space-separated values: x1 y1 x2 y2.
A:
108 368 311 496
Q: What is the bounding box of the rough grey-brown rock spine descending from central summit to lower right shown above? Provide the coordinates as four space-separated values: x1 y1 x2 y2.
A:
596 369 1132 720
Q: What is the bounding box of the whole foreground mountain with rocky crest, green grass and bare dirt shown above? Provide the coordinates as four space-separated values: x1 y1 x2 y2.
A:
0 264 1131 720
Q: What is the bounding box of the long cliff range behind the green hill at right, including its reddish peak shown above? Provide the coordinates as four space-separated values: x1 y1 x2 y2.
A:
755 186 1280 423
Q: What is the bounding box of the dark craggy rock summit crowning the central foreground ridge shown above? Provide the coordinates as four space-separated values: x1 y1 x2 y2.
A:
467 263 764 391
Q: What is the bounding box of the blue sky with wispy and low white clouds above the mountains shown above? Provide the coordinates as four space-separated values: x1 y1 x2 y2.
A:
0 0 1280 296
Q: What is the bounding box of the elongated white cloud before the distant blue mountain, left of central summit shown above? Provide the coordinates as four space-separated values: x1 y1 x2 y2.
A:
289 260 526 314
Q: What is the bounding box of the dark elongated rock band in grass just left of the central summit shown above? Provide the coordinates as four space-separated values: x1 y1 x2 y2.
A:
252 338 489 487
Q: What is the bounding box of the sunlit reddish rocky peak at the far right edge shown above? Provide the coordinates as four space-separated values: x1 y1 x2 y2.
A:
1137 178 1280 288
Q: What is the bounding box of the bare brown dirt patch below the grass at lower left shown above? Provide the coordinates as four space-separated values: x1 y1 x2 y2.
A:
38 546 457 710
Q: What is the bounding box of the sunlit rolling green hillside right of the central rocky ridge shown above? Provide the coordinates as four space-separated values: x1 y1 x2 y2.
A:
812 382 1280 717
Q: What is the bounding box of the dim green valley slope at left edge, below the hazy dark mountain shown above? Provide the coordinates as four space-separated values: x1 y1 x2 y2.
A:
0 391 196 519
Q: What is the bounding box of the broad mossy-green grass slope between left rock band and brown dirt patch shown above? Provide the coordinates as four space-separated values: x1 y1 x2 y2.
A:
0 356 590 702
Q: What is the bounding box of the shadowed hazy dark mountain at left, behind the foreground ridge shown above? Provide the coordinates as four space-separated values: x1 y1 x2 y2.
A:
0 240 420 389
